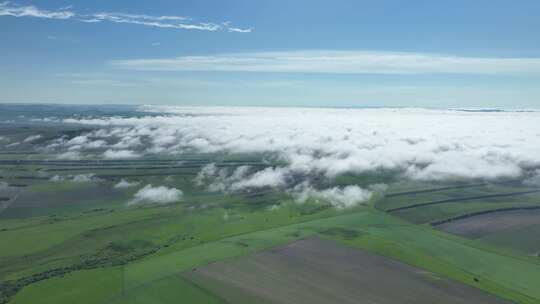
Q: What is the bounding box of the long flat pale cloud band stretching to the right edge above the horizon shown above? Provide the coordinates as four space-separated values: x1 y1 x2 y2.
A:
111 50 540 75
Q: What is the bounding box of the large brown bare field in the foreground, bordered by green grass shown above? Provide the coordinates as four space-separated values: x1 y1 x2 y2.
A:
183 238 507 304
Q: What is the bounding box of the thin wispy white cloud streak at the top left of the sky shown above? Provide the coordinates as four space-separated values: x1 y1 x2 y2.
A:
0 2 252 33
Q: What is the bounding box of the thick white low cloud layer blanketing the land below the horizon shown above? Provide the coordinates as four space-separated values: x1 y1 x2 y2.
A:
50 106 540 207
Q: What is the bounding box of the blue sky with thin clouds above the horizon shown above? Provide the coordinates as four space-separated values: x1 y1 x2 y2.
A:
0 0 540 108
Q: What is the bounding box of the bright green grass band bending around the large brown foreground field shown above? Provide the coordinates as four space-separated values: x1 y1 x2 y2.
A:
6 209 540 303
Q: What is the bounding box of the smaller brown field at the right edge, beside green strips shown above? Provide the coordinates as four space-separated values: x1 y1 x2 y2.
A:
437 210 540 239
